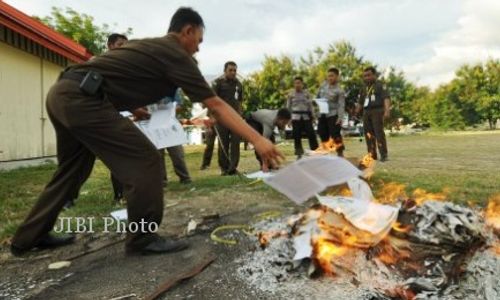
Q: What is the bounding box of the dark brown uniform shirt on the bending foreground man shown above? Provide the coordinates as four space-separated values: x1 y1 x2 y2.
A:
71 34 215 110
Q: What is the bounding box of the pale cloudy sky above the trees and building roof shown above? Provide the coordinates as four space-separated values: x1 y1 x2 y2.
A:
4 0 500 87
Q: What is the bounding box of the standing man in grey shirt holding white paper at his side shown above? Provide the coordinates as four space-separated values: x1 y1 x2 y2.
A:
318 68 345 156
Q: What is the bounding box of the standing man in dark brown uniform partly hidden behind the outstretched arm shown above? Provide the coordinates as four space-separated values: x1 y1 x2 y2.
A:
212 61 243 175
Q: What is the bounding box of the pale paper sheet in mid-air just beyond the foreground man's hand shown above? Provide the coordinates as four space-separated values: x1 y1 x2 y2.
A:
264 156 363 204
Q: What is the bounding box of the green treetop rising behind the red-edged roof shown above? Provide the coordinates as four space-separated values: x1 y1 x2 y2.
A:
35 7 132 55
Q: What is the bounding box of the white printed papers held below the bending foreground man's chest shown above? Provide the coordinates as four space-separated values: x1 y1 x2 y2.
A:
134 102 188 149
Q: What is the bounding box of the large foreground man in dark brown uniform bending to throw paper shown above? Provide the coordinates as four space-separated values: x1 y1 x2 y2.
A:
11 8 283 255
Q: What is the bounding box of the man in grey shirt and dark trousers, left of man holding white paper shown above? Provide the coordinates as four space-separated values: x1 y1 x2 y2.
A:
286 76 318 159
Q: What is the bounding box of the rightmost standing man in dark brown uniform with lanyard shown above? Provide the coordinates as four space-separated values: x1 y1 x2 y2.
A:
356 67 391 161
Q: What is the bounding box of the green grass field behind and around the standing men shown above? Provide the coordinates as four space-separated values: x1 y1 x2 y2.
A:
0 131 500 244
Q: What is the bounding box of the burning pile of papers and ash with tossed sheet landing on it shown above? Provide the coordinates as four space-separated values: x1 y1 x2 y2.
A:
235 156 500 299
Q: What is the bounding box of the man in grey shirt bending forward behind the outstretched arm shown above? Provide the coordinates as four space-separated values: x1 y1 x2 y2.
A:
246 108 292 171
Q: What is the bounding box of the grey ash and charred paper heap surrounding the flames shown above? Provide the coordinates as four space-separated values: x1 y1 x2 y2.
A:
236 202 500 300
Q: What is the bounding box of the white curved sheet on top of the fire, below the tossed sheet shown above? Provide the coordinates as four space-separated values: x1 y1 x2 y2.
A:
317 196 399 234
